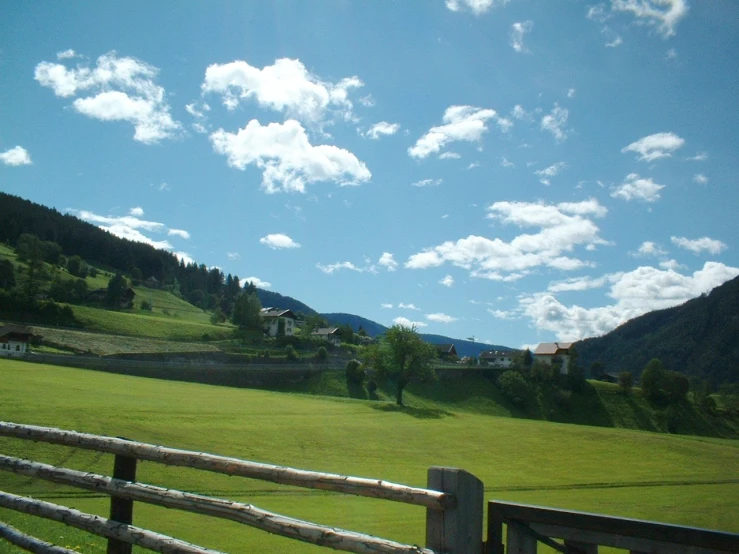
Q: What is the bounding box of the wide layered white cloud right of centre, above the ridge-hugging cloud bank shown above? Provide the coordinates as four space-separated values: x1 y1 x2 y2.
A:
405 199 608 281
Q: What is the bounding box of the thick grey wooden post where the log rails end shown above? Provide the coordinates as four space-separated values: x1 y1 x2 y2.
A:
426 467 484 554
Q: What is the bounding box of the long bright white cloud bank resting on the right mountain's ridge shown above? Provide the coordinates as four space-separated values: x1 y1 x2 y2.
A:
519 262 739 340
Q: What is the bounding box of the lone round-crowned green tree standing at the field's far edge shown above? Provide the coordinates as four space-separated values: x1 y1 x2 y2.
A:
365 325 436 406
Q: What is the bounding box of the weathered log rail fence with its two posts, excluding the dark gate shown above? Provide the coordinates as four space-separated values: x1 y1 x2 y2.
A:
0 422 483 554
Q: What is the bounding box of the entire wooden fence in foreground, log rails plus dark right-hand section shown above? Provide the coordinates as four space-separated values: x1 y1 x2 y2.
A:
0 422 739 554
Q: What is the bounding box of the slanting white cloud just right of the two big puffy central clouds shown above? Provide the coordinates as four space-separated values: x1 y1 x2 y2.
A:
408 106 496 159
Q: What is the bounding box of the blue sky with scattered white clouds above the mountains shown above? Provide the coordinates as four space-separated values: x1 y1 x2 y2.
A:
0 0 739 347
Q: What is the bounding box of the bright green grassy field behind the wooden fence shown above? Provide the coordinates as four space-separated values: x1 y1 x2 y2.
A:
0 361 739 553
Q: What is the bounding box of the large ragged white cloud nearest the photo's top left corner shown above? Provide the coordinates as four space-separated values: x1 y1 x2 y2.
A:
34 52 182 144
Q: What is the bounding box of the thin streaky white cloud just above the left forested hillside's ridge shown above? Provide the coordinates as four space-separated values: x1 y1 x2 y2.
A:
67 208 192 252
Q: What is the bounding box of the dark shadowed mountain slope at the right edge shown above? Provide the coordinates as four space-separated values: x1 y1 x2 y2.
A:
575 277 739 385
